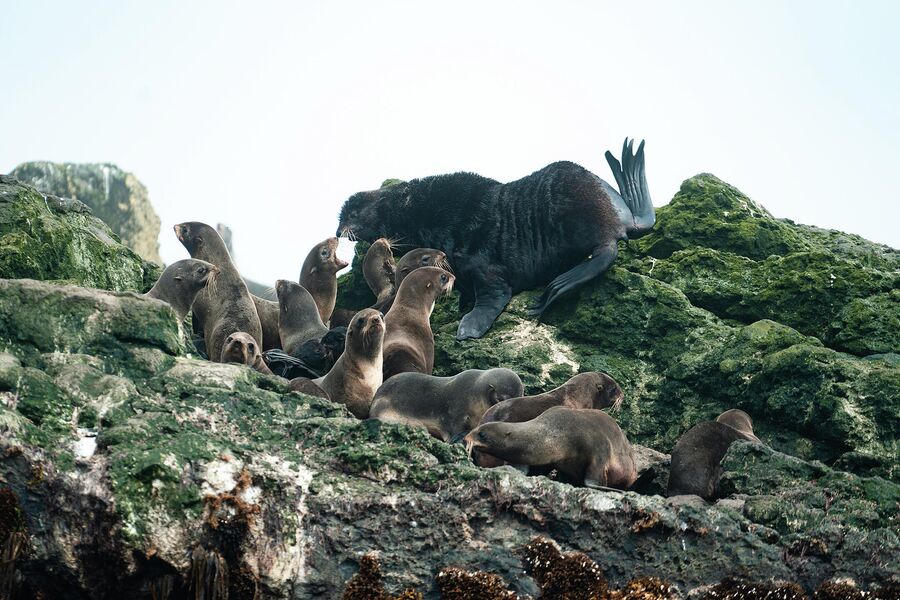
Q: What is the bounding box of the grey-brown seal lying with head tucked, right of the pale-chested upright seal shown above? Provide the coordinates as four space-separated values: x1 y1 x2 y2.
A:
369 369 525 442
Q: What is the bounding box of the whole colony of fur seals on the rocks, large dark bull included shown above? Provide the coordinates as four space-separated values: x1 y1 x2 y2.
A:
147 140 760 499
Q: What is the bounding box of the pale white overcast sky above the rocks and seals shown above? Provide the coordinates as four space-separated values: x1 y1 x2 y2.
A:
0 0 900 285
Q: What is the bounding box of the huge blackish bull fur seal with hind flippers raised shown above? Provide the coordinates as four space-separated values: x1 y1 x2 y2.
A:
337 140 656 339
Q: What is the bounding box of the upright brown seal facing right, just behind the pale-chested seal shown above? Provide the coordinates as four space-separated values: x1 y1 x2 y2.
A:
384 267 454 380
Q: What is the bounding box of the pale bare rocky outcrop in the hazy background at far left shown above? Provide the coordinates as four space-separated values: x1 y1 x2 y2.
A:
10 162 162 264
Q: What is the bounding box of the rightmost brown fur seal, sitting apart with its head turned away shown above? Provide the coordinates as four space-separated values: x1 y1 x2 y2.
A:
666 409 760 500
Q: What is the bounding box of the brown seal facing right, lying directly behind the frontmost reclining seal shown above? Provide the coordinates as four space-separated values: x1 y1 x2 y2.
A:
481 371 625 423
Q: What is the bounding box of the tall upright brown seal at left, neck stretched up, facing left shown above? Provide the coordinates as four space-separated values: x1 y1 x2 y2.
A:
174 221 262 362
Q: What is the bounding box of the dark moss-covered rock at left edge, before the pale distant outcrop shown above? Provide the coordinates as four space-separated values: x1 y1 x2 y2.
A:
0 175 160 291
